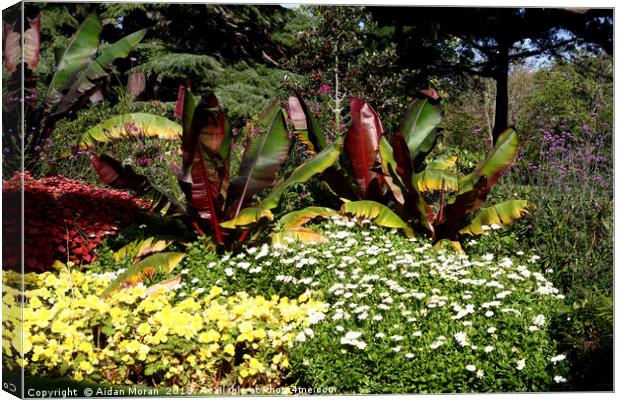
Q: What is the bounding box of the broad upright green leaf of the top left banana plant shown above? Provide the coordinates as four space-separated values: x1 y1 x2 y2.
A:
46 14 103 103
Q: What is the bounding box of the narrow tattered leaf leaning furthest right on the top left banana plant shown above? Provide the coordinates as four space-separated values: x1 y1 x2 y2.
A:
54 29 146 114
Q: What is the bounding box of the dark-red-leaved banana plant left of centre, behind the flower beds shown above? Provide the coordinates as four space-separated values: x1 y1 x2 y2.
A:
91 87 341 249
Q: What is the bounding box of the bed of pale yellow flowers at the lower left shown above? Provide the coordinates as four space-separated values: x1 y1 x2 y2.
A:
2 266 327 389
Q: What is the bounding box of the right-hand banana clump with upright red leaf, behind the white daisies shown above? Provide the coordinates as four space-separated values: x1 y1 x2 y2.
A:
289 90 529 241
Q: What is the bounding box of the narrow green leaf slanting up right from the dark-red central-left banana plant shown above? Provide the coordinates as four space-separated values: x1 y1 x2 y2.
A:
259 143 340 209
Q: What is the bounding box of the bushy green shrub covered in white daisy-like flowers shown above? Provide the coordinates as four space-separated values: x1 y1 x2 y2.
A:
185 218 566 393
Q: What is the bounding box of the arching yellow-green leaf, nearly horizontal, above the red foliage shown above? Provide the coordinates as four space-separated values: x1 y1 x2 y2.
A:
80 113 182 148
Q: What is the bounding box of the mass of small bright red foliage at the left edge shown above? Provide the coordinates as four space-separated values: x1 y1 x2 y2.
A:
2 172 148 272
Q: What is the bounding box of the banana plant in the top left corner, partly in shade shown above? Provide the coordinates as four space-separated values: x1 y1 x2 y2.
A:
3 12 146 175
